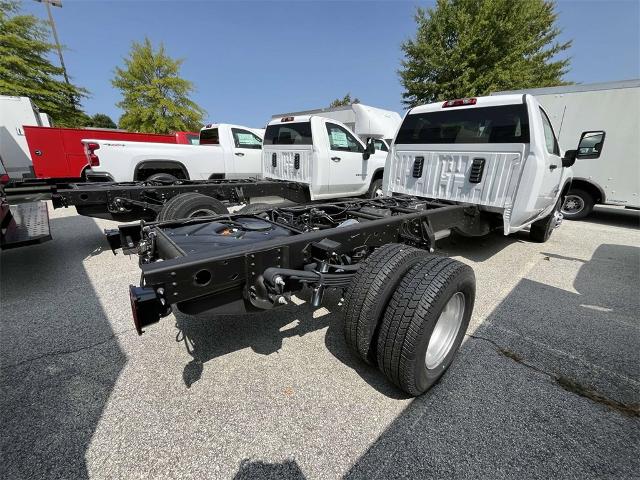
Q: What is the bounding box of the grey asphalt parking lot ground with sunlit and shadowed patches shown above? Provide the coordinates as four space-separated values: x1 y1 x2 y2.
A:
0 202 640 479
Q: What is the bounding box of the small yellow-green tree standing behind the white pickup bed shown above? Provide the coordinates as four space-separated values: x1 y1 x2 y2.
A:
111 38 205 133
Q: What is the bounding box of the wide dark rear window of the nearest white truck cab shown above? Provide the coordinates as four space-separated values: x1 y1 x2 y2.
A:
395 104 529 144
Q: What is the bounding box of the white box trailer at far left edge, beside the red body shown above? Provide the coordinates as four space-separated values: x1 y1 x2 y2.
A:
0 95 51 179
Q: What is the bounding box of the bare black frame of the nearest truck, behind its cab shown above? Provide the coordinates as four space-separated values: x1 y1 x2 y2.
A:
105 196 491 334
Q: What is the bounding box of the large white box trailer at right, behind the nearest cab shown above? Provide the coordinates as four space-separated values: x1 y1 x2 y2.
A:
494 79 640 219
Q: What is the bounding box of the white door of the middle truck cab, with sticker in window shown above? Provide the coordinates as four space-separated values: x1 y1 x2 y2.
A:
326 122 369 195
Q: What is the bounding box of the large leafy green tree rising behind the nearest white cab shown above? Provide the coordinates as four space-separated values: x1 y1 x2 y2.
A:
398 0 571 106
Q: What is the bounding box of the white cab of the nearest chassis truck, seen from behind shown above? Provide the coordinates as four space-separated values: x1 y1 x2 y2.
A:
384 95 578 235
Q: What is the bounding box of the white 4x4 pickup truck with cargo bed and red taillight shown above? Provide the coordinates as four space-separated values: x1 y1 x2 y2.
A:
82 123 262 182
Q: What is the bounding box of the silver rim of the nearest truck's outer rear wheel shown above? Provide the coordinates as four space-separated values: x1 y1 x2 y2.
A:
424 292 466 370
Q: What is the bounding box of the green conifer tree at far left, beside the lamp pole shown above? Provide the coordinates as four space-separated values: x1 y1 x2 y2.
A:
0 0 87 127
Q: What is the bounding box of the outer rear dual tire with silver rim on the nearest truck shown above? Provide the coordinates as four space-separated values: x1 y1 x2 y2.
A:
376 257 476 396
